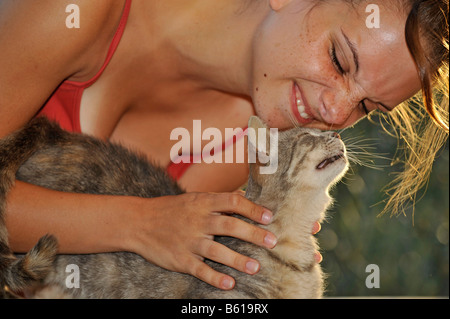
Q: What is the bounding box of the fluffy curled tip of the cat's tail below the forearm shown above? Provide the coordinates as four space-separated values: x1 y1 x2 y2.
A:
0 235 58 292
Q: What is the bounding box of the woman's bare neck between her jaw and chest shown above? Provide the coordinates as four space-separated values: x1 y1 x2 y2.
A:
139 0 270 95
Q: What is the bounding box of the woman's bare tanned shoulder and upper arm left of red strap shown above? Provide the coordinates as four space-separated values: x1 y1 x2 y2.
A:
0 0 125 137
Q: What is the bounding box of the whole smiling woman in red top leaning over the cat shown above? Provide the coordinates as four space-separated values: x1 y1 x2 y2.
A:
0 0 448 289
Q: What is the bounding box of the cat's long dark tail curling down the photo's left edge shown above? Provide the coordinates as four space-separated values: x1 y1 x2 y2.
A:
0 118 64 296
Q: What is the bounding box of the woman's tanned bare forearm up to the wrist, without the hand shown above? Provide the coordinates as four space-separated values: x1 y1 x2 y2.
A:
5 181 133 254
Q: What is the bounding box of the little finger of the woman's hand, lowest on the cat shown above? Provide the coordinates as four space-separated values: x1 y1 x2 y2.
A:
189 258 235 290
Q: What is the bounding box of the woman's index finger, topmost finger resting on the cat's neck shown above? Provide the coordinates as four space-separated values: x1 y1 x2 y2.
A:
215 193 273 225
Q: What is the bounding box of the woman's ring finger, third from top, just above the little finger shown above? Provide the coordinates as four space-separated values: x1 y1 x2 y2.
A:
198 239 260 275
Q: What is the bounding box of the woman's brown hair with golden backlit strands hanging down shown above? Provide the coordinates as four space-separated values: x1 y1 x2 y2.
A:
382 0 449 216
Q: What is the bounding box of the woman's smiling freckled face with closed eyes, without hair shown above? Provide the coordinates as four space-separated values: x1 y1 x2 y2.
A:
252 0 420 130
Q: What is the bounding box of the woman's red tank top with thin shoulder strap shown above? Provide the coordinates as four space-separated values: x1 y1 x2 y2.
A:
37 0 244 180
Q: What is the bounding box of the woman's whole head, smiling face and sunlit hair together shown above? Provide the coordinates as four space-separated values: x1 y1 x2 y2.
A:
253 0 448 215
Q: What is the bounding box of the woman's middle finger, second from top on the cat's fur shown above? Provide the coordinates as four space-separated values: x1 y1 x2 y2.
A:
209 215 277 248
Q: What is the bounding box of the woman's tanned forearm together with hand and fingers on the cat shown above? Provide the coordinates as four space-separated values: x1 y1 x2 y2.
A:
5 182 276 289
